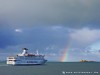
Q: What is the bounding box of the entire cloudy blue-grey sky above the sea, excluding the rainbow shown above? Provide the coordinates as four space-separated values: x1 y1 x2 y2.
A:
0 0 100 61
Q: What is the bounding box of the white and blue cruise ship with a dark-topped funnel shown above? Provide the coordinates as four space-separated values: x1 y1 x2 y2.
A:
7 48 47 65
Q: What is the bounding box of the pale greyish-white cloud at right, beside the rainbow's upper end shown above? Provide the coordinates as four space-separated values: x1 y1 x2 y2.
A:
69 28 100 48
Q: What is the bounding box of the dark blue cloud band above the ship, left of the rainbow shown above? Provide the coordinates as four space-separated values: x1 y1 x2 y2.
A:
0 25 69 48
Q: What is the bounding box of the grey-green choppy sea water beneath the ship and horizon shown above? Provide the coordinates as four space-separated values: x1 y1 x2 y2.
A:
0 62 100 75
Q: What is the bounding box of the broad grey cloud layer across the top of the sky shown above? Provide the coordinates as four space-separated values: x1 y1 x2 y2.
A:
0 0 100 28
